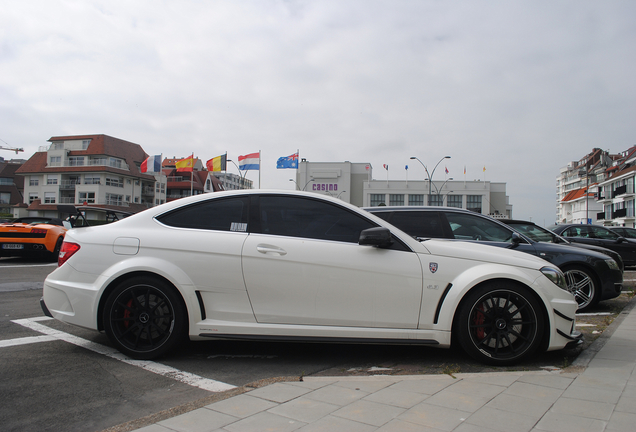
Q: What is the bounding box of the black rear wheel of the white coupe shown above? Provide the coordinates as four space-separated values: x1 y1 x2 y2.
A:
102 276 188 360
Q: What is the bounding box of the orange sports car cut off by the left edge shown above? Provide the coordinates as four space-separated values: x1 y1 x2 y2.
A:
0 217 66 261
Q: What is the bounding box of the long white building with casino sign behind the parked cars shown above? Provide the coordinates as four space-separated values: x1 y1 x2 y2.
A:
296 159 512 219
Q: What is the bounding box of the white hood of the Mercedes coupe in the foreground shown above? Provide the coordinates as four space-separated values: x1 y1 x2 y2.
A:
421 239 554 270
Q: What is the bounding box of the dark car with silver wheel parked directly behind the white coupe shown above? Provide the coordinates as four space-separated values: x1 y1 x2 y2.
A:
366 206 623 312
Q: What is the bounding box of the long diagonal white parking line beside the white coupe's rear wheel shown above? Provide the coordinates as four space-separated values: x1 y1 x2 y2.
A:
11 317 236 393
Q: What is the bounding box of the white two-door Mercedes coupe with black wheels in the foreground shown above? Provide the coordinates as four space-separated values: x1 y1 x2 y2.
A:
41 189 582 365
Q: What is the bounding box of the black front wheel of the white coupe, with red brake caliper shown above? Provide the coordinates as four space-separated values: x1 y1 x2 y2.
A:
455 281 545 366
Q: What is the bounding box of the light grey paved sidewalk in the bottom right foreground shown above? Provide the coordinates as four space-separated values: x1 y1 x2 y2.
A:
132 302 636 432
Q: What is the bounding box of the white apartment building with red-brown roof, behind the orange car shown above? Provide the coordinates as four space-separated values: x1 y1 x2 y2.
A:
14 135 167 217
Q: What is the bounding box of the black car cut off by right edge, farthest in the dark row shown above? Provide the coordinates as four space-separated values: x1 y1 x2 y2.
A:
548 224 636 267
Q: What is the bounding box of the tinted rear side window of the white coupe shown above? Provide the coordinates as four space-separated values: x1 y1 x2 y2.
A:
157 197 249 232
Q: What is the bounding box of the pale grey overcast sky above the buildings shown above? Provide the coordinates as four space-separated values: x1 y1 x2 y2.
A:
0 0 636 224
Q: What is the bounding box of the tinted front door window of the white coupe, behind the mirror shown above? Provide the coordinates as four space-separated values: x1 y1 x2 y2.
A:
259 195 377 243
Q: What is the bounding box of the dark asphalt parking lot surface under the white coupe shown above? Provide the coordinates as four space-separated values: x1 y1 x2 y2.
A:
0 260 636 431
